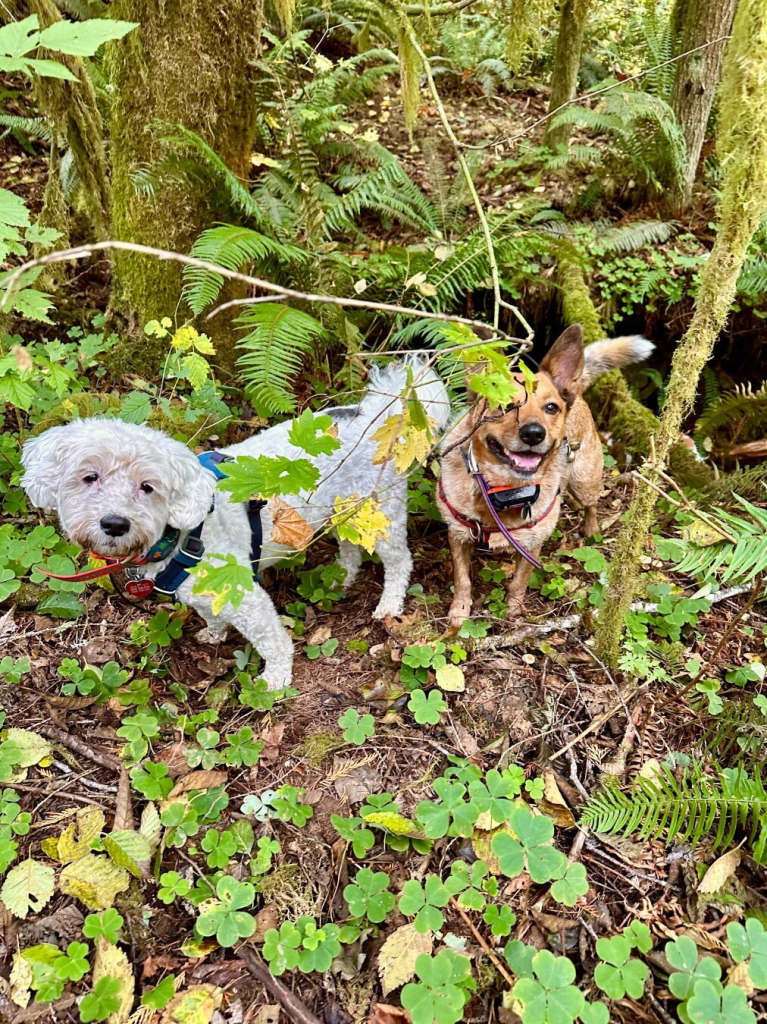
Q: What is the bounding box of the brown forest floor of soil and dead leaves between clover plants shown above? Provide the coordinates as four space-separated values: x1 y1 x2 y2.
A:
0 75 767 1024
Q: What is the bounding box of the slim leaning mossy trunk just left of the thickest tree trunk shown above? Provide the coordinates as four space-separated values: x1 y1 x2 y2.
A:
0 0 110 237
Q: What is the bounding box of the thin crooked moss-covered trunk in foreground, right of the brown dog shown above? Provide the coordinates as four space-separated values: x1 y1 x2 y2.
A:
597 0 767 669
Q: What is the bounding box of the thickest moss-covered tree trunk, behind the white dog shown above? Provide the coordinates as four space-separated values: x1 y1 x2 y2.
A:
108 0 263 350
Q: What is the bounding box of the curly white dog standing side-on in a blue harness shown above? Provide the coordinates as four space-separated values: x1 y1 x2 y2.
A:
22 361 450 689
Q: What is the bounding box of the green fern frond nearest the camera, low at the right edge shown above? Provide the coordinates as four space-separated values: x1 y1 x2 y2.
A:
581 763 767 849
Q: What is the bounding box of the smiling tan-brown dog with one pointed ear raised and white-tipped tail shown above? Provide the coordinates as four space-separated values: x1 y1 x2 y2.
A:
437 324 654 627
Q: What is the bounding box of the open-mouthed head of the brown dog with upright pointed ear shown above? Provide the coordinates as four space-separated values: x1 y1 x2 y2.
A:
472 324 584 480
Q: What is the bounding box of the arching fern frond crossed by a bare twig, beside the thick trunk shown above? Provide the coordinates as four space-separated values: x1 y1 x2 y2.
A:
183 224 308 315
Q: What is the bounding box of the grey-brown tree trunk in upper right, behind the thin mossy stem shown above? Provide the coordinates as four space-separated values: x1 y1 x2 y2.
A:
670 0 737 216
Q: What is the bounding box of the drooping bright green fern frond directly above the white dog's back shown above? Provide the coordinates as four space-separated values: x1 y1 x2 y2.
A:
236 302 328 414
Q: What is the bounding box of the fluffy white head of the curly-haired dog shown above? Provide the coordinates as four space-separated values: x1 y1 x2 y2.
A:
22 419 216 557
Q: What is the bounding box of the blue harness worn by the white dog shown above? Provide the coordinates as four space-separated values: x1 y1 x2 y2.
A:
134 452 267 601
